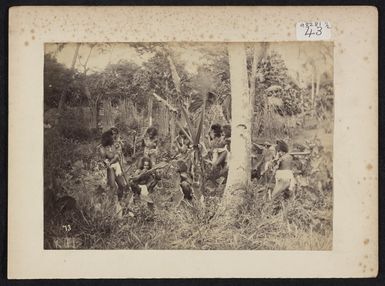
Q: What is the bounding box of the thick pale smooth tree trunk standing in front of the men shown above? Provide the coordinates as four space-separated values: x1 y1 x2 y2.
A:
219 43 252 224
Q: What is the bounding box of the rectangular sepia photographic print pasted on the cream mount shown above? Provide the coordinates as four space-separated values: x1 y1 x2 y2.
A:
43 41 332 250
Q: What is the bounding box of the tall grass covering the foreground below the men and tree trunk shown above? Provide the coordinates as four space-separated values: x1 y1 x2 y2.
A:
44 124 333 250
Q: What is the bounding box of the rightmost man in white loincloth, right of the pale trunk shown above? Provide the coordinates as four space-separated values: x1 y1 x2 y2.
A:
271 140 295 199
